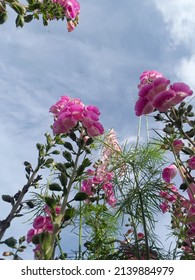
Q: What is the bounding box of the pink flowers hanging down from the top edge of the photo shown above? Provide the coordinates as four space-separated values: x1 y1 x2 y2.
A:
53 0 80 32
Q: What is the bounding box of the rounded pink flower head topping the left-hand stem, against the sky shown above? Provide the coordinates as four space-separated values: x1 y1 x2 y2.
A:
50 96 104 137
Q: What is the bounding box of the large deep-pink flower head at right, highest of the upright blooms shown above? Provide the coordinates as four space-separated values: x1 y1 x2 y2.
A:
134 70 193 116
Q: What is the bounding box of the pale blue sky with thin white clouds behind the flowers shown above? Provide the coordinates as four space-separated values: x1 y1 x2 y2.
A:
0 0 195 258
